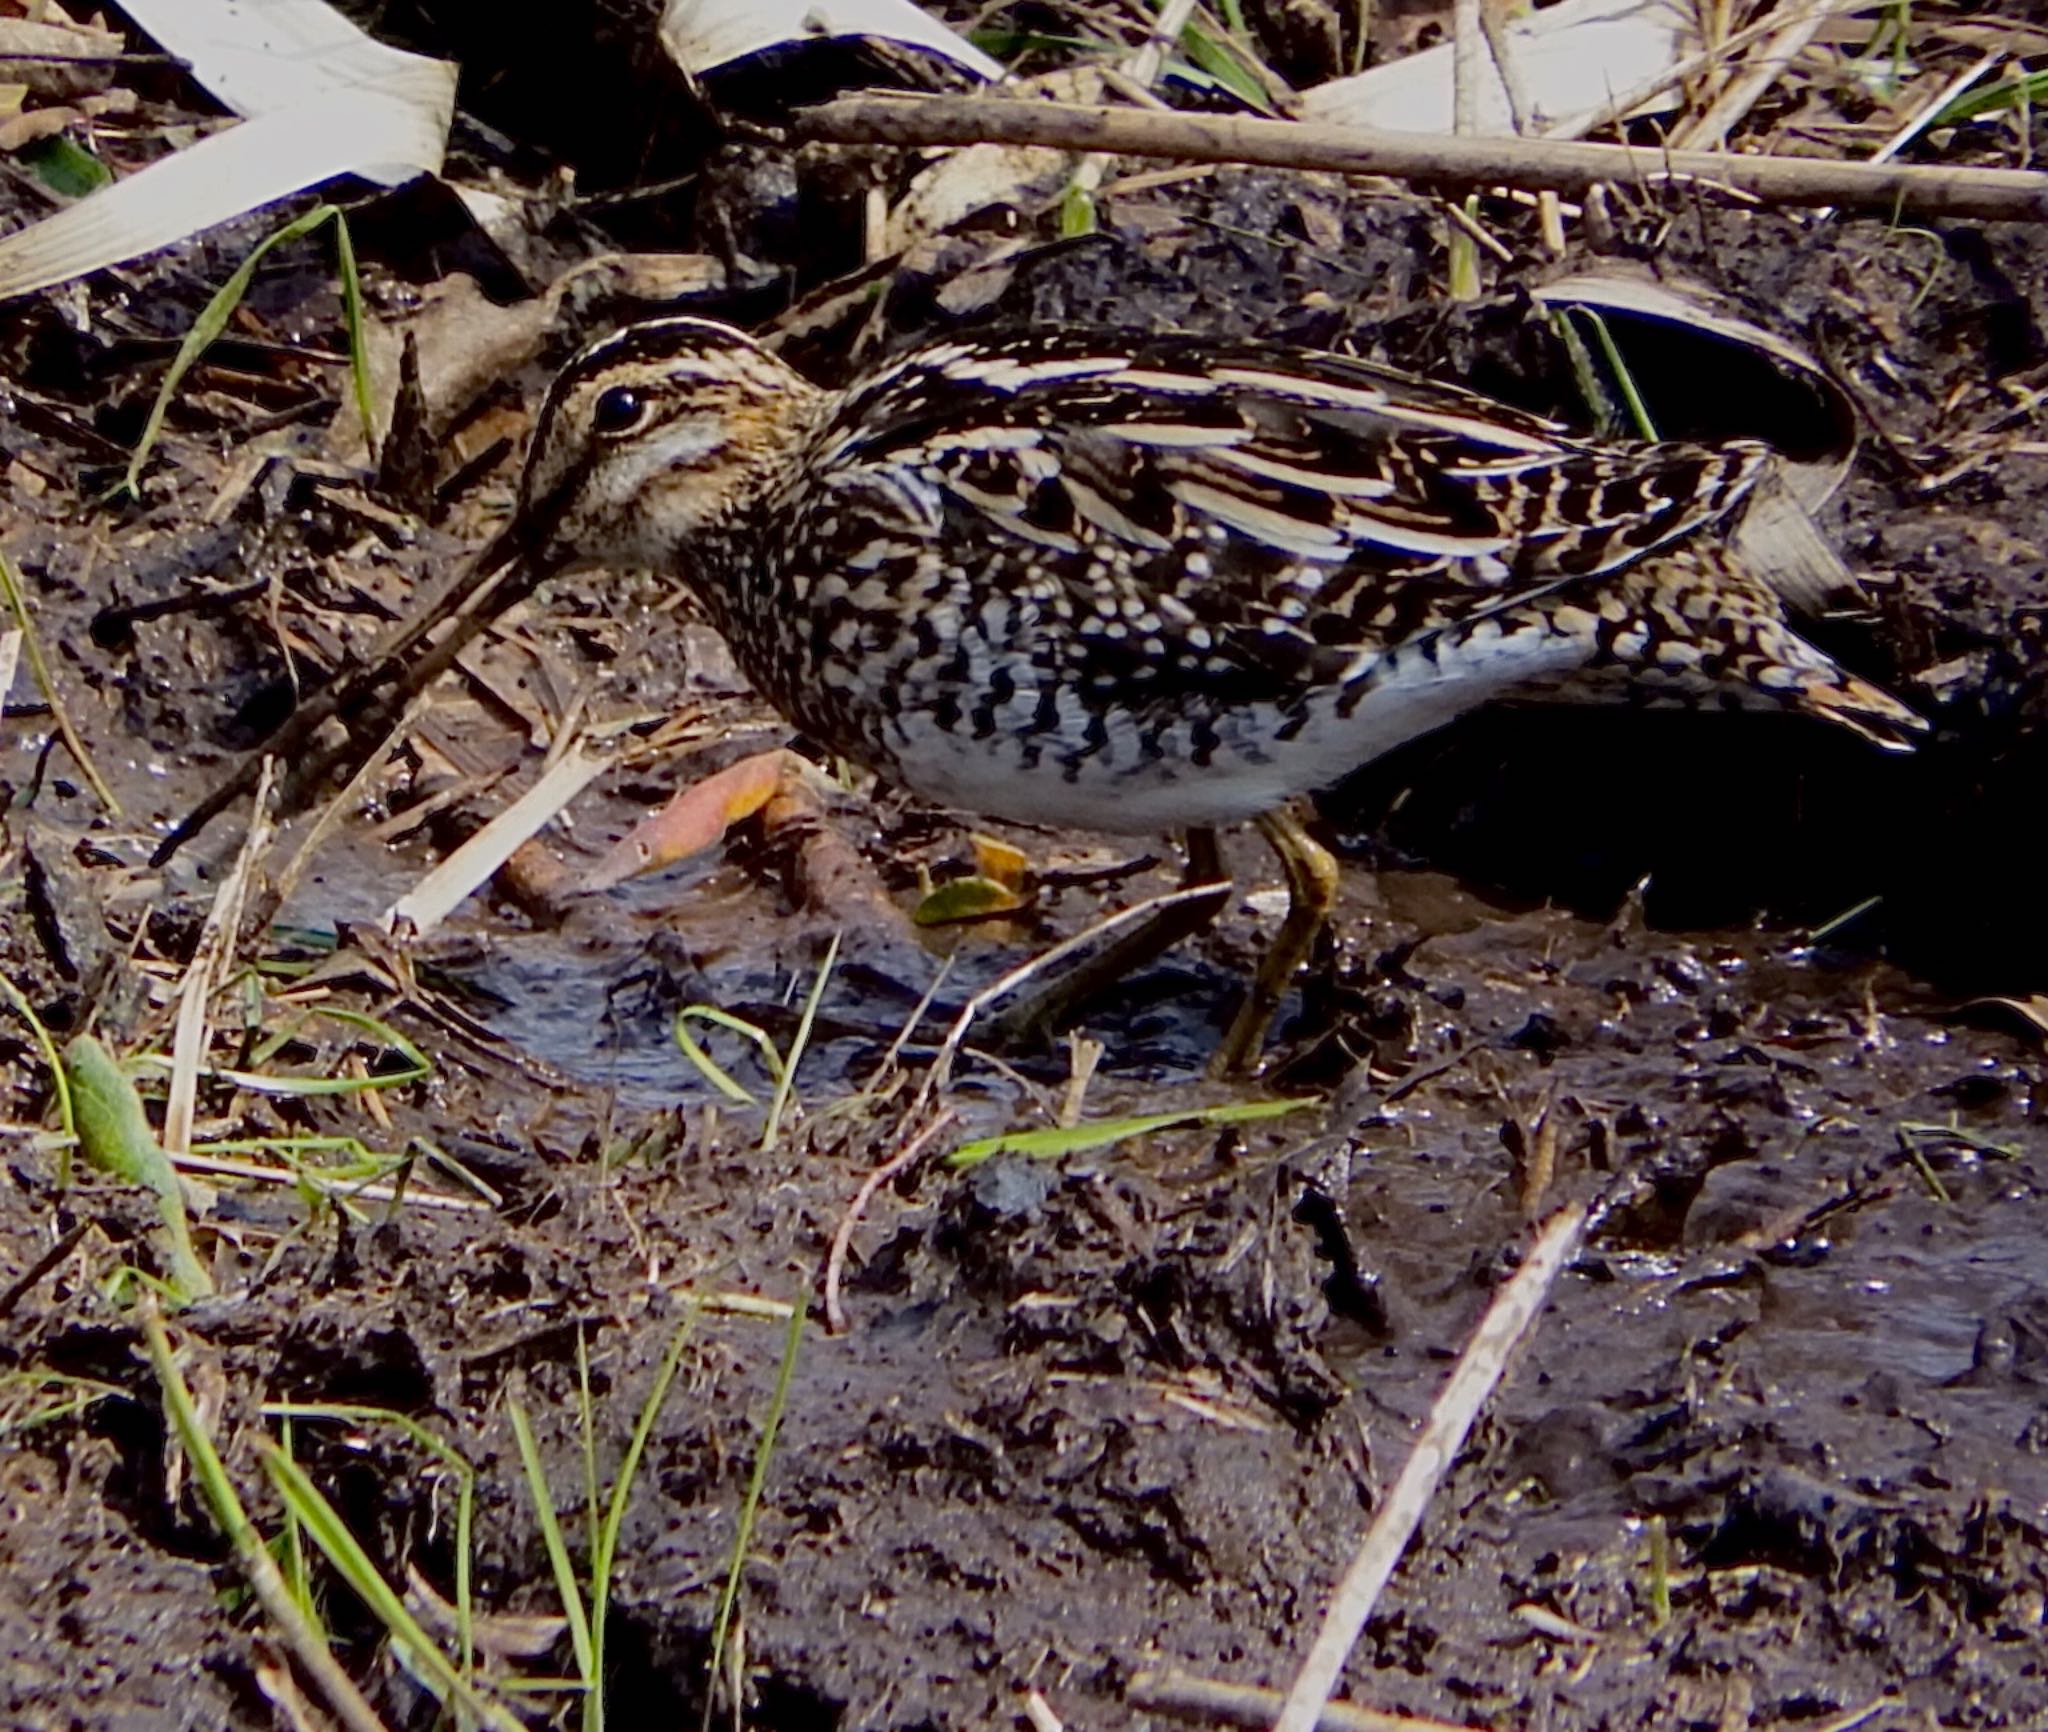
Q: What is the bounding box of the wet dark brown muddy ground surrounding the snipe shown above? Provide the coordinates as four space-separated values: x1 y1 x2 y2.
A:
0 3 2048 1732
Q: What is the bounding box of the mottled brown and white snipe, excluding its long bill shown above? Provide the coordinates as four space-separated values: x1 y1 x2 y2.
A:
163 315 1925 1073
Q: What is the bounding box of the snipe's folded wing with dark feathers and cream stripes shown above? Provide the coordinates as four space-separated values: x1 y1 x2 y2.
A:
813 332 1772 696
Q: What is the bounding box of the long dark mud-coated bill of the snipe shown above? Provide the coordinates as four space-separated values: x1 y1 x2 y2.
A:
150 514 555 866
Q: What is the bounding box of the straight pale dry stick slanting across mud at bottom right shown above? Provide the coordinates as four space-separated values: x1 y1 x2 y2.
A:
1274 1204 1585 1732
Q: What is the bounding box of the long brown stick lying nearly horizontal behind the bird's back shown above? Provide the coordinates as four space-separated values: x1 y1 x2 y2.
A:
791 94 2048 223
